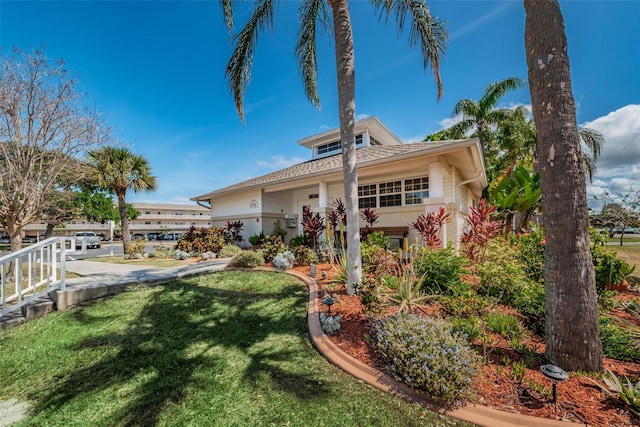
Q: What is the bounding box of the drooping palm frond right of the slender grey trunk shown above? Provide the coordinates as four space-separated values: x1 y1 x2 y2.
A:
372 0 447 99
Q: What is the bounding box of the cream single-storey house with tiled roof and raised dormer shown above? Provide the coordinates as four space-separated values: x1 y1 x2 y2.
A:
191 117 487 251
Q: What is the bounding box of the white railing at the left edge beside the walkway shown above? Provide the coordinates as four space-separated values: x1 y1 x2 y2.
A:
0 237 74 316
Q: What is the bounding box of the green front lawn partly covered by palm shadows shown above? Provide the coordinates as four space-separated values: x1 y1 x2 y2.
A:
0 272 470 427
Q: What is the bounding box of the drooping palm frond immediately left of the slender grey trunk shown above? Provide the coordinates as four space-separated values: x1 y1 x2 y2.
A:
295 0 328 108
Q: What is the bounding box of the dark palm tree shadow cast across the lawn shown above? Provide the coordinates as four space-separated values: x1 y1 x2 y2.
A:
33 274 328 426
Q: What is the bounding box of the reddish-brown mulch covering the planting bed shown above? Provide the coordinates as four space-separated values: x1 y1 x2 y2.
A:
294 264 640 426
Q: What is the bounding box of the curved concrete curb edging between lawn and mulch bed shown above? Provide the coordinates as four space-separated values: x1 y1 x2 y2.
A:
282 268 585 427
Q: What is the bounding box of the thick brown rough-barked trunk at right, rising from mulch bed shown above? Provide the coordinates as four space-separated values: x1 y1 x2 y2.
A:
524 0 603 371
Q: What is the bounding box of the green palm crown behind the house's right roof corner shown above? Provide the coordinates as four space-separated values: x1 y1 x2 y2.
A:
453 77 525 154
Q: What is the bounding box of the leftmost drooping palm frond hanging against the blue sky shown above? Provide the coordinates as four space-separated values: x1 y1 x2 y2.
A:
225 0 274 123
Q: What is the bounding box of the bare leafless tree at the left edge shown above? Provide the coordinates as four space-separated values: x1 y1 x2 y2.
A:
0 49 109 251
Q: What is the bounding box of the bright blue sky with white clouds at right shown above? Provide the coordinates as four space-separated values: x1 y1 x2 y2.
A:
0 0 640 211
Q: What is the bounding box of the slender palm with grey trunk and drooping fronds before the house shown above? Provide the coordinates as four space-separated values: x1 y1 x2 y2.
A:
220 0 446 294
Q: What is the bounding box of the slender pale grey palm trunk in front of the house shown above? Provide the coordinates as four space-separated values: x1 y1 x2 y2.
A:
329 0 362 295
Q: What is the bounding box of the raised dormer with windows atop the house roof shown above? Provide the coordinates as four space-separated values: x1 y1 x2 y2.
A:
298 116 402 159
